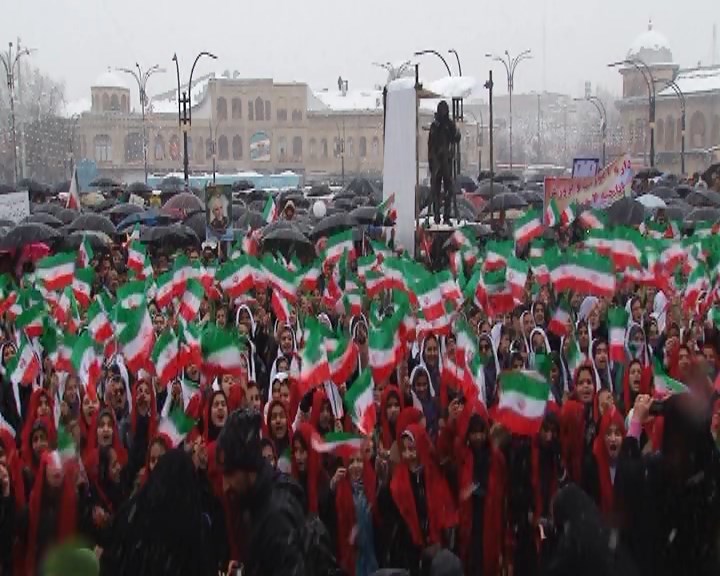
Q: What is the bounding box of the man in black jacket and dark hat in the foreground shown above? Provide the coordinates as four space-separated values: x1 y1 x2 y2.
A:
217 409 306 576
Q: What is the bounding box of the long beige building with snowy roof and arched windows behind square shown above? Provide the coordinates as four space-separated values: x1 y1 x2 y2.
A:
74 71 479 181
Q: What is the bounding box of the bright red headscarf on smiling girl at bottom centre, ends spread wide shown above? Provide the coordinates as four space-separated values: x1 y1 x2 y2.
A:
390 424 458 548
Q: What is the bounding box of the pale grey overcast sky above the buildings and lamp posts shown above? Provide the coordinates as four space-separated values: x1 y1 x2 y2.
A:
0 0 720 106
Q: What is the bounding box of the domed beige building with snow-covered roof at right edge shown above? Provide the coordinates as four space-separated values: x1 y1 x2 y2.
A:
616 21 720 174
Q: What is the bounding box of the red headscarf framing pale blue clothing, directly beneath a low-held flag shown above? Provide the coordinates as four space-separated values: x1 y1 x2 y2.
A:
335 458 377 576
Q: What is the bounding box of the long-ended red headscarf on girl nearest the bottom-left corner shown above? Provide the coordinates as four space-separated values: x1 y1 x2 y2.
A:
25 452 77 574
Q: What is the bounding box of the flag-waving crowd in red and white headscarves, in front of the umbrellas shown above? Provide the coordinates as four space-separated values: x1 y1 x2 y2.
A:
0 183 720 576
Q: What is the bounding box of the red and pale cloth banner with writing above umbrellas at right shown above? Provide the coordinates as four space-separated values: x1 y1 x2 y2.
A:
545 155 633 211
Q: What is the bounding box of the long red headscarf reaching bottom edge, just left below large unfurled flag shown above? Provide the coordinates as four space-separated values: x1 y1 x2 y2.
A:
455 402 507 576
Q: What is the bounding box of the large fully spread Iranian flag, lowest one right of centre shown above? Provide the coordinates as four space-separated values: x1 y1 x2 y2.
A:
495 370 550 436
